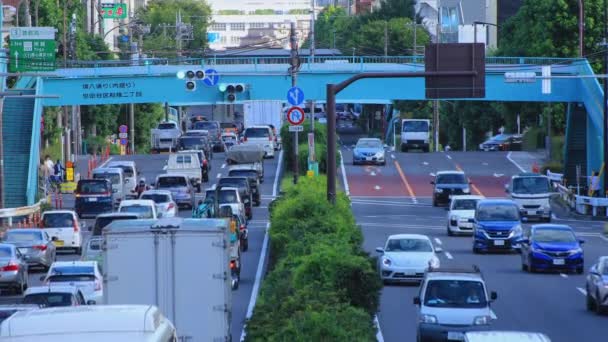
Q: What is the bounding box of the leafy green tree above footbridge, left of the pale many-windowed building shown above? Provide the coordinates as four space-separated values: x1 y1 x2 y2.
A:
136 0 211 57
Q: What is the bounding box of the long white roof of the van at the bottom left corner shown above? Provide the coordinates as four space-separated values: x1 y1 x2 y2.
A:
0 305 166 337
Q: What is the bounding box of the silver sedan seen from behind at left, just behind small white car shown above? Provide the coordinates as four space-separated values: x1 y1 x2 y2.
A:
3 228 56 270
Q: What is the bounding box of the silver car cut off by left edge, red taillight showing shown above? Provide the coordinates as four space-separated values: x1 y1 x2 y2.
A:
0 243 28 295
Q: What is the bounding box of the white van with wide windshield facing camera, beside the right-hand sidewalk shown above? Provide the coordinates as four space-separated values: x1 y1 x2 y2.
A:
505 173 552 222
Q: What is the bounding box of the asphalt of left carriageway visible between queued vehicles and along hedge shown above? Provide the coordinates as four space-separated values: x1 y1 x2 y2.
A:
0 152 279 341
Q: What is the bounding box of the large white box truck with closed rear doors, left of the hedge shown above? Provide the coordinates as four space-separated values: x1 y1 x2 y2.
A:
102 218 232 342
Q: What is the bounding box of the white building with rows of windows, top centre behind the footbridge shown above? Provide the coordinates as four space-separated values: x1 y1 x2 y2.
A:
207 0 319 50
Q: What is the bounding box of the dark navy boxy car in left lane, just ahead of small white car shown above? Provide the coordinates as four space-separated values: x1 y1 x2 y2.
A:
74 179 114 218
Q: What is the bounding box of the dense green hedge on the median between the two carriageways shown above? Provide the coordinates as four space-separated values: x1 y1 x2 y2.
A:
247 177 382 341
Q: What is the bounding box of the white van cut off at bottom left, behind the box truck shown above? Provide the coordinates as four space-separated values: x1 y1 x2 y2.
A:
0 305 177 342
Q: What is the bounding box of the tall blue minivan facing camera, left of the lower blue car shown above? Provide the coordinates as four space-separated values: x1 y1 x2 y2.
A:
471 200 523 254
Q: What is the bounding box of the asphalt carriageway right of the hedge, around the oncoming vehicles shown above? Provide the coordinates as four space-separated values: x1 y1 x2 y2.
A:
342 147 608 342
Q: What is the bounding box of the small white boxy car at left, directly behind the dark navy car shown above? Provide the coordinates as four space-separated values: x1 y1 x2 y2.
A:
41 210 86 254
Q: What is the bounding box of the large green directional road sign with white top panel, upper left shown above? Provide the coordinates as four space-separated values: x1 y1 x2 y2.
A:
9 27 56 72
